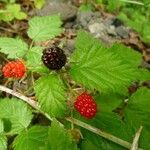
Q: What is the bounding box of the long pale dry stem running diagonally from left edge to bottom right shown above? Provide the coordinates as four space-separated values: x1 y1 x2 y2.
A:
0 85 142 150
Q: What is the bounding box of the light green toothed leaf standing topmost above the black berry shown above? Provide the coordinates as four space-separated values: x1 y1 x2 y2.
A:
28 15 62 41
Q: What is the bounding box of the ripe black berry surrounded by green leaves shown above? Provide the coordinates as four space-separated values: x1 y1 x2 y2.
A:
42 47 67 70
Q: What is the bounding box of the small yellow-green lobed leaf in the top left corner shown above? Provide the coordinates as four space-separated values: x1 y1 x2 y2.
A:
0 4 27 22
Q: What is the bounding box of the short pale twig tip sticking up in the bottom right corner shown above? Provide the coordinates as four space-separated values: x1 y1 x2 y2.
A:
130 126 143 150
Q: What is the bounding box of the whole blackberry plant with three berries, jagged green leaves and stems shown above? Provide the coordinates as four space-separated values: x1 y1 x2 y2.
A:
0 15 150 150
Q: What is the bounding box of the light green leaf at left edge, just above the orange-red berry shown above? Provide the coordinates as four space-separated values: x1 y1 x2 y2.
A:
0 37 28 58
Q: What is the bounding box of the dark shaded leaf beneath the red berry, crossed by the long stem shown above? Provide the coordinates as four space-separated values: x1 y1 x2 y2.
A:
78 111 133 150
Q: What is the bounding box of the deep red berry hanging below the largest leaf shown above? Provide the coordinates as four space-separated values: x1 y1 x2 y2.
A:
74 92 97 119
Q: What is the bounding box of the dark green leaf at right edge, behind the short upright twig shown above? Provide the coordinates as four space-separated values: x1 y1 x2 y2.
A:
125 87 150 149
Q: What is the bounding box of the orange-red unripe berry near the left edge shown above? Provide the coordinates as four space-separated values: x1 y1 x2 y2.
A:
2 60 26 78
